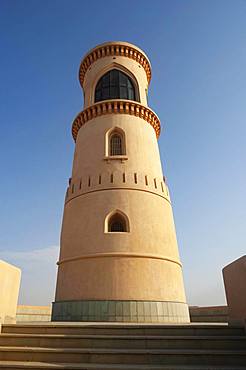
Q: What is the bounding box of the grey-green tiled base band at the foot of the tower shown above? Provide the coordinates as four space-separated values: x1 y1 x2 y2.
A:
51 300 190 323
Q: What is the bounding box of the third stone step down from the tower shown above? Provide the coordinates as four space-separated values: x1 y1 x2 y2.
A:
0 347 246 368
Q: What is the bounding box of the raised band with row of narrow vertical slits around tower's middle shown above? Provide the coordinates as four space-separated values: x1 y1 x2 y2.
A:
66 171 170 203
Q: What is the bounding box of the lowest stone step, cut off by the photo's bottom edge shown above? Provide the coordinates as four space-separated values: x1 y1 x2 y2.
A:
0 361 245 370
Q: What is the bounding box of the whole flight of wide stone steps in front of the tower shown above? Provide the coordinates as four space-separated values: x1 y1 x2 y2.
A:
0 323 246 370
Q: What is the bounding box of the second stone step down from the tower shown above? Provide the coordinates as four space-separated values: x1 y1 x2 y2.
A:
0 333 246 349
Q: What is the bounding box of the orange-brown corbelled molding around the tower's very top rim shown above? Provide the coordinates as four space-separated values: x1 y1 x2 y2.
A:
79 43 151 87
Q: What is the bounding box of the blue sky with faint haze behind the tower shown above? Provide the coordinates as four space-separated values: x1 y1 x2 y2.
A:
0 0 246 305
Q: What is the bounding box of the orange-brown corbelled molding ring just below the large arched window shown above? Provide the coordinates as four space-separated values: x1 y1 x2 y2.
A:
72 99 161 141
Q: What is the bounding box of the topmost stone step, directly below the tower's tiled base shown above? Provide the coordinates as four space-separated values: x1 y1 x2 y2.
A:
2 323 245 336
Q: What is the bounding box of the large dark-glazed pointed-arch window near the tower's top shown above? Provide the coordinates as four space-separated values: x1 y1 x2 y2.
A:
95 69 136 103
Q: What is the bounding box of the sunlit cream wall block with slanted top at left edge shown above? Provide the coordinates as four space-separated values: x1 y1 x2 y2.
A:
0 260 21 324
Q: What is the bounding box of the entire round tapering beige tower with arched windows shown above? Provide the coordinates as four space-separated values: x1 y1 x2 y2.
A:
52 42 189 322
